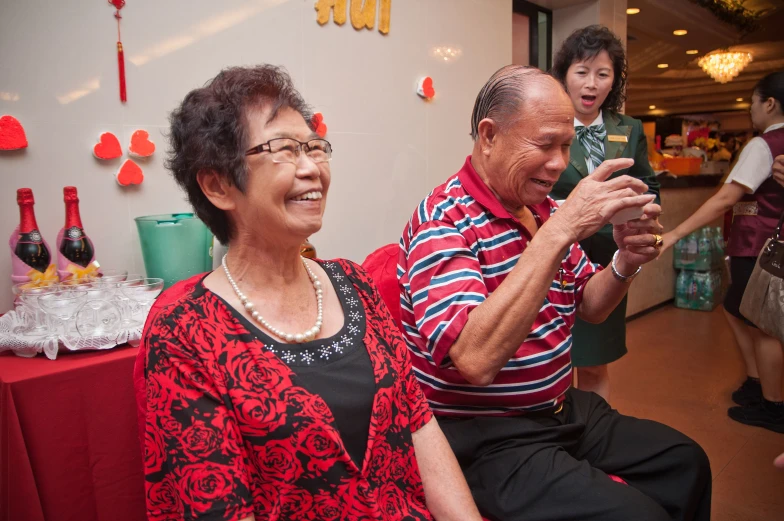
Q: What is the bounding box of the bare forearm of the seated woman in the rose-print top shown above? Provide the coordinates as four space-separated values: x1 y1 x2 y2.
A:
412 417 482 521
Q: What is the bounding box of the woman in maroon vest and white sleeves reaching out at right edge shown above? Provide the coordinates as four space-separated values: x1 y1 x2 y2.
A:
664 72 784 432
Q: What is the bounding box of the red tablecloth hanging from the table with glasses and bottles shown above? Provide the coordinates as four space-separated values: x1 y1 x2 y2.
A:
0 347 145 521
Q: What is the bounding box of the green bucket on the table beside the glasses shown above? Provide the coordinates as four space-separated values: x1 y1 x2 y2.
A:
134 213 213 288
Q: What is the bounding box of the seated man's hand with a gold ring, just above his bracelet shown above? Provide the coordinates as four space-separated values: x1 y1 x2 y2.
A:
613 203 664 275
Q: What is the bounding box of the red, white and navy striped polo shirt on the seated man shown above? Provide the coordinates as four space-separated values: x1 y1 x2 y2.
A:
397 156 601 416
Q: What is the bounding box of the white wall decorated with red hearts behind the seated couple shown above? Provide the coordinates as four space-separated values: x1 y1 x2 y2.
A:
0 0 512 310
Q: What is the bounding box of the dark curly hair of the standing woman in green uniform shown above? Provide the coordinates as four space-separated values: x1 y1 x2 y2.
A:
550 25 628 112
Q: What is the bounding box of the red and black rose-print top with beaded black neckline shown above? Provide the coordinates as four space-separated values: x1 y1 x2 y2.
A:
144 260 433 521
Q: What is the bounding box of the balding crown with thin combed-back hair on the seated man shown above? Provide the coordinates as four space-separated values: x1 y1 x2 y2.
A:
471 65 569 141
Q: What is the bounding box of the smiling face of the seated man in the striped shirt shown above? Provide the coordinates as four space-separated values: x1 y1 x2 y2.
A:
486 83 574 209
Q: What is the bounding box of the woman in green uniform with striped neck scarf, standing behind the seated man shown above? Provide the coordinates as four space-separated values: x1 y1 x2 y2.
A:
550 25 659 400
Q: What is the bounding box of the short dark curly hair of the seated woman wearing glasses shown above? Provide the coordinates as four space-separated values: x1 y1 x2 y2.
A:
166 64 312 244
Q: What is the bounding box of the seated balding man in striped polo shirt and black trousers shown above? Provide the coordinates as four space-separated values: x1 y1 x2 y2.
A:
398 66 711 521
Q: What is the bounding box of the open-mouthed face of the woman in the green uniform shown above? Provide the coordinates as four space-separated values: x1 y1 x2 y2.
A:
566 51 615 124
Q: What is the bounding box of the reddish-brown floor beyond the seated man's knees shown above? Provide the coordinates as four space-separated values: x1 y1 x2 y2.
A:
610 306 784 521
